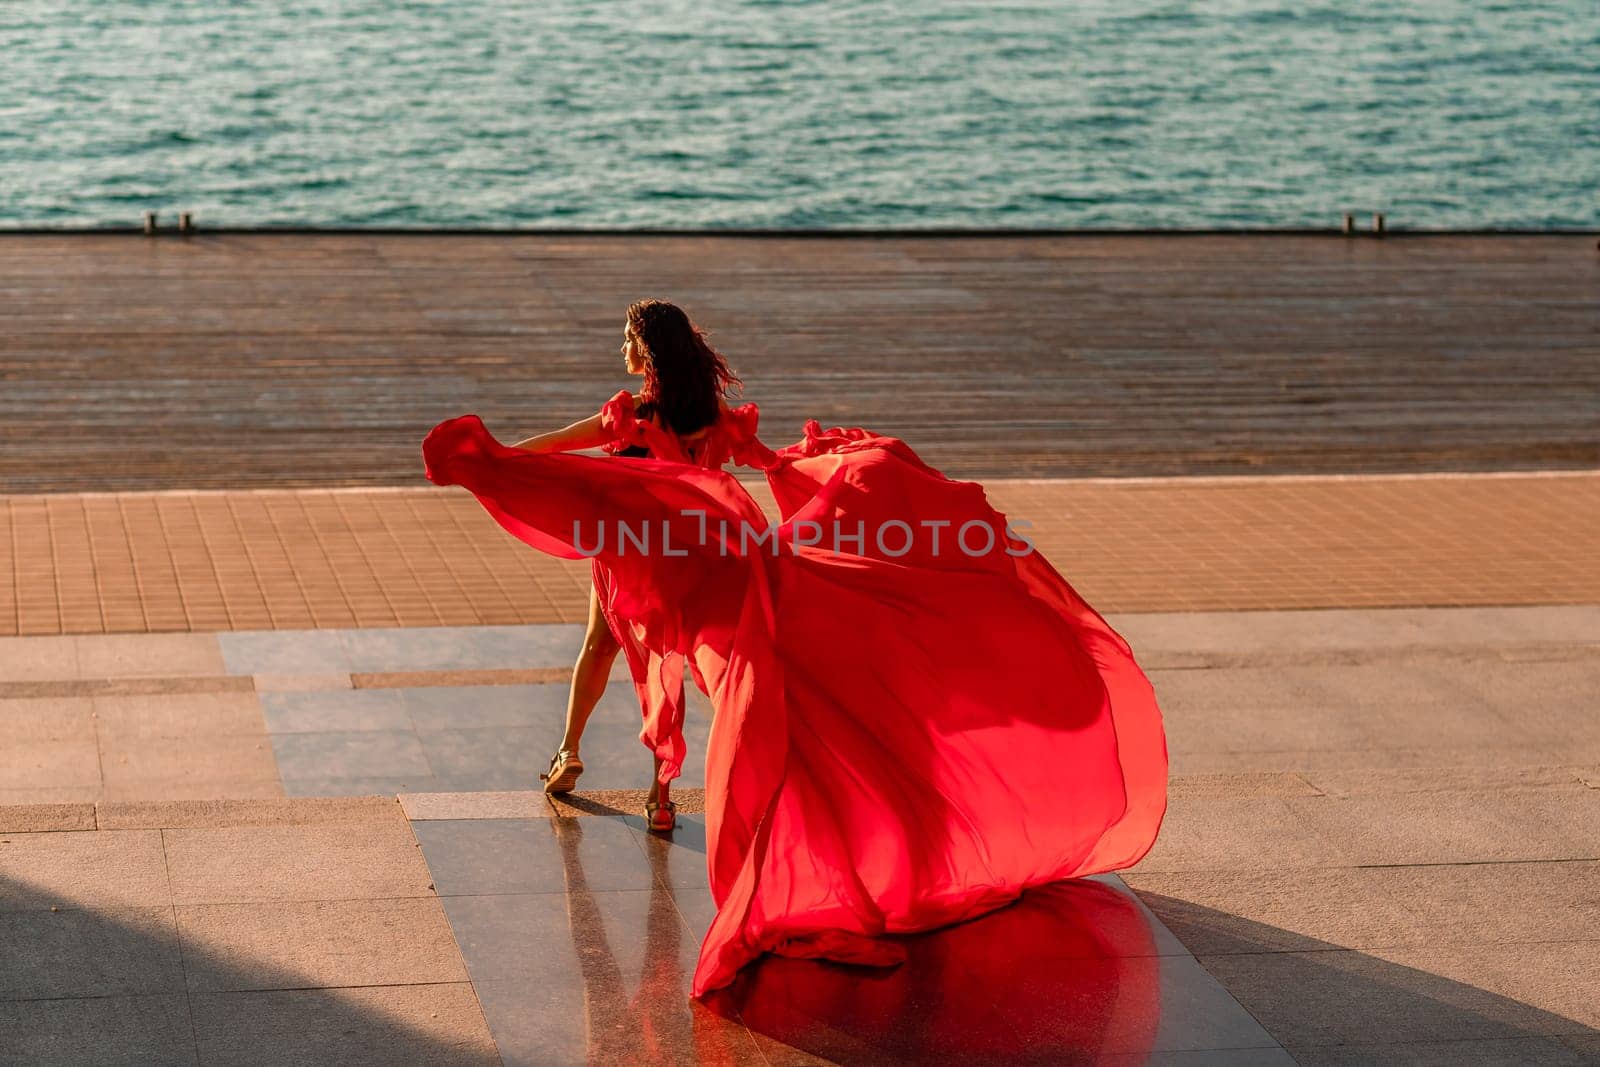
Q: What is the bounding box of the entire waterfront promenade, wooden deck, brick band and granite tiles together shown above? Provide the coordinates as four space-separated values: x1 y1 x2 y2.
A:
0 234 1600 1067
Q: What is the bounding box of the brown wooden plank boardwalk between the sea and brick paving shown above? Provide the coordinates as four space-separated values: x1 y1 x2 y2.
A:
0 234 1600 493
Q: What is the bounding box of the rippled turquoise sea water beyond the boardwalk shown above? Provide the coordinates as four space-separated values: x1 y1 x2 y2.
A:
0 0 1600 227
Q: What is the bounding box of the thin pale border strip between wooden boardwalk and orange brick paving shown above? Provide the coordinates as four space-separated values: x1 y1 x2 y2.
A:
5 467 1600 499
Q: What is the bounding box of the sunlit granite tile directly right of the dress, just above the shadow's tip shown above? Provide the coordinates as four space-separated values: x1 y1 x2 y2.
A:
1133 797 1346 872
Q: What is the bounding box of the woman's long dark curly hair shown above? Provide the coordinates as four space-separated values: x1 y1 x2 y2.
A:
627 299 744 434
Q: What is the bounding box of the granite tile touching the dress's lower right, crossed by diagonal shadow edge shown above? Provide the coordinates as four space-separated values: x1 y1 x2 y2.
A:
1125 870 1435 957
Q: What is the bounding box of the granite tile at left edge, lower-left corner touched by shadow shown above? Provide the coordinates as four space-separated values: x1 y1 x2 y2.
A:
0 830 171 912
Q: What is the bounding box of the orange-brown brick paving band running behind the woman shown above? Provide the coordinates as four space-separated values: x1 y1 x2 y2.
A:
0 472 1600 635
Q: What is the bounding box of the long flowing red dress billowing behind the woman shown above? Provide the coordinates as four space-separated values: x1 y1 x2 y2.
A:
422 392 1166 997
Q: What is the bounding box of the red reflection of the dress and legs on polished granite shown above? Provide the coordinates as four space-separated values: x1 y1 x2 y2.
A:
552 819 1160 1064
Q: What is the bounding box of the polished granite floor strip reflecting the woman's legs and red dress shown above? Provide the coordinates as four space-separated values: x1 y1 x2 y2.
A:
413 816 1293 1067
